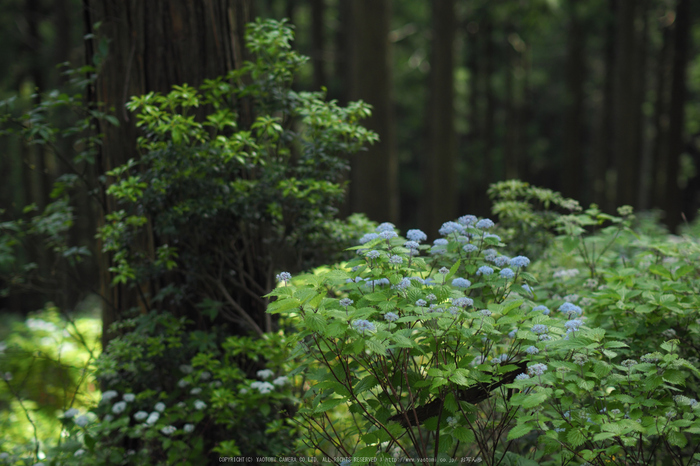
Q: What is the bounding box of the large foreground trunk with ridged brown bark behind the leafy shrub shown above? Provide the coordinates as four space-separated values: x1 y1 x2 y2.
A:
84 0 252 346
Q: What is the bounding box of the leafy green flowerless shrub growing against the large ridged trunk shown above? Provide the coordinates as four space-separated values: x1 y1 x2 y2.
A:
100 20 377 335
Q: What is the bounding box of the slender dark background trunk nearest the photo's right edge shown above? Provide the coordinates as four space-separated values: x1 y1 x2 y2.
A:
664 0 690 232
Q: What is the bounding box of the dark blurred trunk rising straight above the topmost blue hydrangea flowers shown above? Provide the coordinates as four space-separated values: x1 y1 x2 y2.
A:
424 0 457 235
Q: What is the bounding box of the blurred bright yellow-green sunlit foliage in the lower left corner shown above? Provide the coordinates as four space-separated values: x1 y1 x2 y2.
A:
0 305 100 465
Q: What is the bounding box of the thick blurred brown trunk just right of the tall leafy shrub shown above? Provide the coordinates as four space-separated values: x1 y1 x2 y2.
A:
349 0 399 222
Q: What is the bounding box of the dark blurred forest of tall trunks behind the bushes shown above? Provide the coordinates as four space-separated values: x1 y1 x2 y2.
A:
0 0 700 458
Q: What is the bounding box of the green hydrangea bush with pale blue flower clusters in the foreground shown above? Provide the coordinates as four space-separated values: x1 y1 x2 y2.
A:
270 207 700 465
